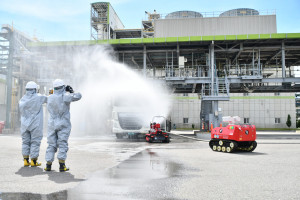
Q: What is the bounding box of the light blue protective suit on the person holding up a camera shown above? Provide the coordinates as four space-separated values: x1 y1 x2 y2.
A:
46 87 81 163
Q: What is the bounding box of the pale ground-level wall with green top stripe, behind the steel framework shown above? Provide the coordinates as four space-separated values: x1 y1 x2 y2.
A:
171 93 299 129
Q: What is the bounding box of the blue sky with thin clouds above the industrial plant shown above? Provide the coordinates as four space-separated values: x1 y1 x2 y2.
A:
0 0 300 41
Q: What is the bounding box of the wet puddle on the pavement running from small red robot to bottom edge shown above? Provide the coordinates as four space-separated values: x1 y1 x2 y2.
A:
0 149 182 200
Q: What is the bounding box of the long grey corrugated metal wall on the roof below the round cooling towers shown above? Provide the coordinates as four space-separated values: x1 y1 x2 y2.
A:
154 15 277 37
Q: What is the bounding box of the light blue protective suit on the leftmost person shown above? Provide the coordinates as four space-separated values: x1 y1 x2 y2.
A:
19 89 47 158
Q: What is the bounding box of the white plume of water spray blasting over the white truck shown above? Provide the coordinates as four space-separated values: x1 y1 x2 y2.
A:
71 46 170 135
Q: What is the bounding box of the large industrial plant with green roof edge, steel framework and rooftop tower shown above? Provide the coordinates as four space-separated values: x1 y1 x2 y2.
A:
0 2 300 130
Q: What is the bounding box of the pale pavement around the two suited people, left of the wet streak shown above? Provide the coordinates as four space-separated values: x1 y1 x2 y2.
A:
0 134 148 194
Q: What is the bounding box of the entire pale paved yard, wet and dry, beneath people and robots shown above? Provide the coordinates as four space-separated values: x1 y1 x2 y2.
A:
0 132 300 200
